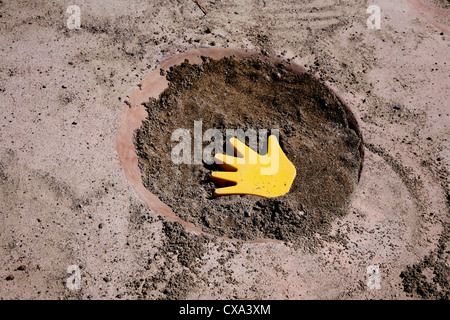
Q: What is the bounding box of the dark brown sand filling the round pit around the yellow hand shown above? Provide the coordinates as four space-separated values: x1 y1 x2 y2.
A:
118 48 363 242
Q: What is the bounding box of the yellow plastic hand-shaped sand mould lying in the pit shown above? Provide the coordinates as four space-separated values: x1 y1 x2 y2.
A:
211 135 297 198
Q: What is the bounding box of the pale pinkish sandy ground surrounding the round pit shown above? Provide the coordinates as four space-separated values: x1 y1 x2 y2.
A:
0 0 450 299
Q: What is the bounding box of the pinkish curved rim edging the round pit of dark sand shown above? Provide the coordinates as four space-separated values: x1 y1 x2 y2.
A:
116 48 364 243
